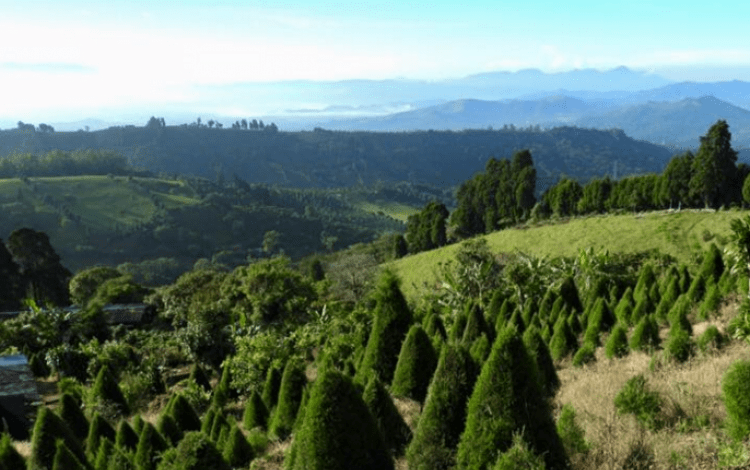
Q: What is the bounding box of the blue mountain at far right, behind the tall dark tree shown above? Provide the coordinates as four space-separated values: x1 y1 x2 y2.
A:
575 96 750 148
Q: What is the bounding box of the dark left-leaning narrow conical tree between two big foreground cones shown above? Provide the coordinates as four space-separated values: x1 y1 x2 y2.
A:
362 376 412 455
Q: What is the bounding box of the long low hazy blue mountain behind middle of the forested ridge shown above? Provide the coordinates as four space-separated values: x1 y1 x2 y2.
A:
322 96 601 131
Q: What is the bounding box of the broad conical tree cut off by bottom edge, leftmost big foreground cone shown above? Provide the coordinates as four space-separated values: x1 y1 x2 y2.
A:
285 367 393 470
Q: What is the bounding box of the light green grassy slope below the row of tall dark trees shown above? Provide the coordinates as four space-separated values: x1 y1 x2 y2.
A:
392 210 745 299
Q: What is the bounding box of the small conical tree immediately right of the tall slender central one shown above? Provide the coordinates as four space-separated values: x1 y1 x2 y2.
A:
391 325 437 403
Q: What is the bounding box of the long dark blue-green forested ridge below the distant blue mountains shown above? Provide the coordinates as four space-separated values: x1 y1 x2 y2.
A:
0 124 671 191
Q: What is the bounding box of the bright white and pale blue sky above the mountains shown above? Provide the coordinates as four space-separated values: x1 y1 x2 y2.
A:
0 0 750 125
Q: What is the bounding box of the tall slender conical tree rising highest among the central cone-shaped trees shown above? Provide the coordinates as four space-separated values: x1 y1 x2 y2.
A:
355 271 412 384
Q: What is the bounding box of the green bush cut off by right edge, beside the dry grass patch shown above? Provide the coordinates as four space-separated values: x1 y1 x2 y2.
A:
721 361 750 441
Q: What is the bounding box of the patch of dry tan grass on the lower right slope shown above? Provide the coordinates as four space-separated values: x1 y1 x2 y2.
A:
555 303 748 470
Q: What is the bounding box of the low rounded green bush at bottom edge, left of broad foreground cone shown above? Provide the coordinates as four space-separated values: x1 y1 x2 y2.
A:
157 432 232 470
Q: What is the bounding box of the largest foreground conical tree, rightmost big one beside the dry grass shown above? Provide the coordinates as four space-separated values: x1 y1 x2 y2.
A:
456 328 568 470
